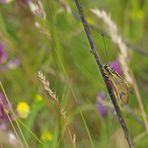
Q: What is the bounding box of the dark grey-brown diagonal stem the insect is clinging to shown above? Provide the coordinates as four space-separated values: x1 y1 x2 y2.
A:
75 0 135 148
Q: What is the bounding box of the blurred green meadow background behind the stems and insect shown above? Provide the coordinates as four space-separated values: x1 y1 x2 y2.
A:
0 0 148 148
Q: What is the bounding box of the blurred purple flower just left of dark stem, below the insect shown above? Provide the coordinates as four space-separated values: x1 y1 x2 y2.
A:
97 91 108 117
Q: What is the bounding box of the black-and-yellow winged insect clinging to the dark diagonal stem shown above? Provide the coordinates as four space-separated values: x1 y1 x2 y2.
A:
103 64 132 105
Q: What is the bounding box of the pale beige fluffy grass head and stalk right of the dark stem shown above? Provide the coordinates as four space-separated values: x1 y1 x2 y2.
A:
92 9 148 133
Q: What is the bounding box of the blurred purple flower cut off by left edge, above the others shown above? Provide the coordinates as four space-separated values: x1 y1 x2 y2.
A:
0 43 8 64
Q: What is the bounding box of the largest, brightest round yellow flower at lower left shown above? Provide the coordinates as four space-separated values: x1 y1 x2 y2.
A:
16 101 30 118
